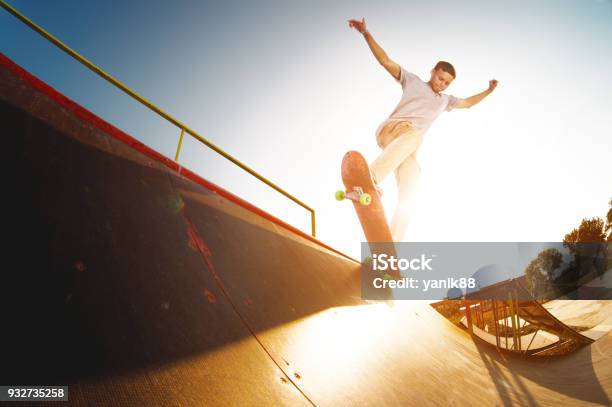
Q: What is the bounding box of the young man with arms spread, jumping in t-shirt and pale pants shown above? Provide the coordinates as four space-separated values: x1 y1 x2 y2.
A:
349 19 497 242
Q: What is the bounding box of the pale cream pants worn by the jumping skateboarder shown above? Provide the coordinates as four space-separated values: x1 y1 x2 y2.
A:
370 121 423 242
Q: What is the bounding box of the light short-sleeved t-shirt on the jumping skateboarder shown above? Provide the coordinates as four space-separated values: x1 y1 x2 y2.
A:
376 67 461 135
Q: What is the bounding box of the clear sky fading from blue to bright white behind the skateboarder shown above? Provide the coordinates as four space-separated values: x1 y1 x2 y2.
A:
0 0 612 255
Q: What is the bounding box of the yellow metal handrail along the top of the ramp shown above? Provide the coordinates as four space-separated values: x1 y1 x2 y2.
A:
0 0 316 237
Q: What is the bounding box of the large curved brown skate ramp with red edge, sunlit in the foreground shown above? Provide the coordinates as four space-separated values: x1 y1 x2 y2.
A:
0 55 612 406
